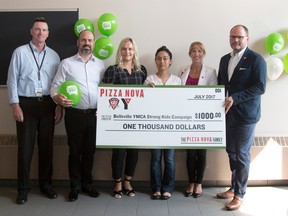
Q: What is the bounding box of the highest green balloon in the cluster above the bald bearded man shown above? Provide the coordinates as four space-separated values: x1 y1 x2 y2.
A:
98 13 118 36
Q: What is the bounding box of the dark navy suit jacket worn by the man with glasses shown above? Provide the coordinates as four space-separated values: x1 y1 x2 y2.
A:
218 48 267 124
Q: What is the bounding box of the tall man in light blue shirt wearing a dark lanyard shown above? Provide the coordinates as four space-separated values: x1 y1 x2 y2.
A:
7 17 62 204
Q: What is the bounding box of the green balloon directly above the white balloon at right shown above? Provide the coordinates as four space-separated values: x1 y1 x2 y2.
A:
265 32 285 55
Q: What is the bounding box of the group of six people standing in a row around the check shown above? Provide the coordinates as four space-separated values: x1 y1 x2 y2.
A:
7 17 266 210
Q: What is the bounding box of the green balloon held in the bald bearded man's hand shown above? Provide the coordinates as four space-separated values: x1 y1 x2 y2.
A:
58 81 81 106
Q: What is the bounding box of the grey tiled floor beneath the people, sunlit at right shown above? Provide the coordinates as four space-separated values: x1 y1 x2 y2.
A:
0 185 288 216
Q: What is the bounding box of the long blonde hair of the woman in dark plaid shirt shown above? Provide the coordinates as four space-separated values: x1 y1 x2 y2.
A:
116 37 141 71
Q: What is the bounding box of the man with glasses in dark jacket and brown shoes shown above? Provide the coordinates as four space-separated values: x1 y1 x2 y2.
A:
217 25 267 210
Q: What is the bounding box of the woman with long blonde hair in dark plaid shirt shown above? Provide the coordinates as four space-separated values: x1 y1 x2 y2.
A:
102 38 147 199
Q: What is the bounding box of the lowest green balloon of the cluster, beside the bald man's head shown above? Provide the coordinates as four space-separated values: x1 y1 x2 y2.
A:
93 37 114 60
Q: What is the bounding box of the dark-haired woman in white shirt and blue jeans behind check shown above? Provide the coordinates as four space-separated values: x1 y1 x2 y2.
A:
145 46 181 200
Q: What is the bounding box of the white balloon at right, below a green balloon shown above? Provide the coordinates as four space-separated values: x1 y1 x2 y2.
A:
266 57 284 80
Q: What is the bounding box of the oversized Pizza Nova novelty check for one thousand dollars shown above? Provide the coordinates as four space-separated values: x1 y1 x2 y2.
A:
96 85 226 149
